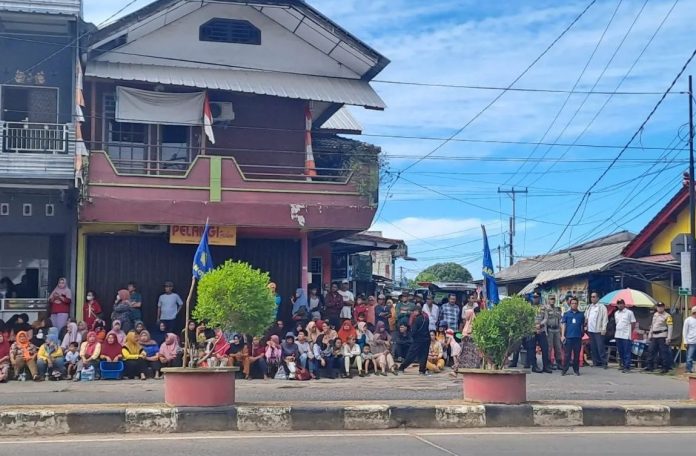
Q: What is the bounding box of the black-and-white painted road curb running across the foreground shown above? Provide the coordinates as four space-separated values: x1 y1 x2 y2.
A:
0 402 696 437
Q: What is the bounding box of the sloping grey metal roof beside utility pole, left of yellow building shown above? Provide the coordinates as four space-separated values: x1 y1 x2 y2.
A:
496 233 632 282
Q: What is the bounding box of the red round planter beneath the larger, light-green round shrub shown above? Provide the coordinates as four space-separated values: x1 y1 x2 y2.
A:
162 367 239 407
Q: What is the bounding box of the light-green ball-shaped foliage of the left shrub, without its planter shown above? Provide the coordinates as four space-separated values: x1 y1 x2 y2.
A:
193 260 275 335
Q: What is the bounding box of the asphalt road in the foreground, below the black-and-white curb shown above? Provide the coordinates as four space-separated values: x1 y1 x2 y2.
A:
5 428 696 456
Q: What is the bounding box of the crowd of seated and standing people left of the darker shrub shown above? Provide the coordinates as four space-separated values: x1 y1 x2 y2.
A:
0 281 480 382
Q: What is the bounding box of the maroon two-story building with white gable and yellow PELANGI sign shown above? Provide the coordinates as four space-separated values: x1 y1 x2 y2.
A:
77 0 388 323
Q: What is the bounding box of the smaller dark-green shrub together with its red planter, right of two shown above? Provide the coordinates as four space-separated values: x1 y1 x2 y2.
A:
458 297 535 404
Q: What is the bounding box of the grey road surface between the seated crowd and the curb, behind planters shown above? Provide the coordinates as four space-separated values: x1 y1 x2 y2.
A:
0 368 688 406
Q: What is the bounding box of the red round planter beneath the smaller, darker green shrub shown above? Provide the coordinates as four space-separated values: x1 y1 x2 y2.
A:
457 369 527 404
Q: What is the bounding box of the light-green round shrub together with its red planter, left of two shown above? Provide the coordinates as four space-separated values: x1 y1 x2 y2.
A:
163 260 275 407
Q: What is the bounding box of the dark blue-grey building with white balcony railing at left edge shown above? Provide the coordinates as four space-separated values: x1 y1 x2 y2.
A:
0 0 81 313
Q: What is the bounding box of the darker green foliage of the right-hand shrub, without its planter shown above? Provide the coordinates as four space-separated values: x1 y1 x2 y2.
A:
471 297 535 369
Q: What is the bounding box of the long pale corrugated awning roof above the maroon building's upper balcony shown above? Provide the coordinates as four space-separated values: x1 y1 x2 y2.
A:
85 61 386 109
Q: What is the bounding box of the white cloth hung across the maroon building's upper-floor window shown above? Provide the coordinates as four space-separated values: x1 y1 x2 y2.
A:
116 87 205 125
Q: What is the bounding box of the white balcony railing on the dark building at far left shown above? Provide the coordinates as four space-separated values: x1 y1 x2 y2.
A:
0 122 70 154
